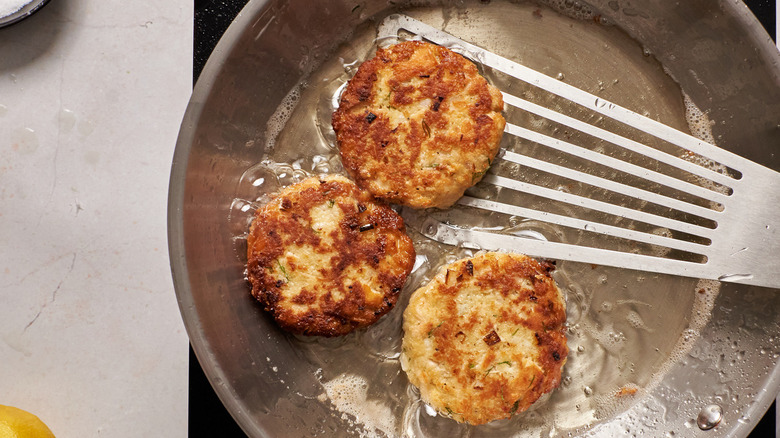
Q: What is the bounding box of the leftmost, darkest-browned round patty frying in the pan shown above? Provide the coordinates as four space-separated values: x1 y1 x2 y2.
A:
247 176 415 336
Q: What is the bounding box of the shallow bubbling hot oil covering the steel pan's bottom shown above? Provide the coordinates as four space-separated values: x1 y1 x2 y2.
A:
230 1 718 436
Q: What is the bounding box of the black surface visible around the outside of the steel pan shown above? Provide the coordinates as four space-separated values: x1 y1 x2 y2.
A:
189 0 776 438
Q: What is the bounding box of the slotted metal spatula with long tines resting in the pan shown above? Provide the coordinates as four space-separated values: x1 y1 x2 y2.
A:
379 15 780 287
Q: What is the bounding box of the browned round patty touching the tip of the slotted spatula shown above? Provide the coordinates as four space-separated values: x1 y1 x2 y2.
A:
333 41 505 208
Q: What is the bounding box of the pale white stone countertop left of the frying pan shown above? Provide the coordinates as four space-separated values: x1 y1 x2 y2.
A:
0 0 193 437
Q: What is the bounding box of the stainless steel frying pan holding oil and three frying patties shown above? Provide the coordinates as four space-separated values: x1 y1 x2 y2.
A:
169 0 780 437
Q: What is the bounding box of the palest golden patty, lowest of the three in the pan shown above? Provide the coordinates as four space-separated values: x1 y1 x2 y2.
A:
401 252 568 424
